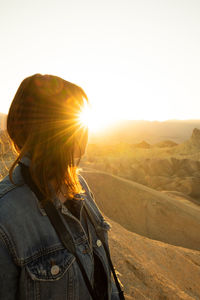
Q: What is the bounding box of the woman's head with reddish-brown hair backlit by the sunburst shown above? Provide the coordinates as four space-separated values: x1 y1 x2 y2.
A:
7 74 88 196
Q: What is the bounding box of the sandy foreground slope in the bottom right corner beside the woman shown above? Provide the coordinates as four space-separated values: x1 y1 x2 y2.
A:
108 220 200 300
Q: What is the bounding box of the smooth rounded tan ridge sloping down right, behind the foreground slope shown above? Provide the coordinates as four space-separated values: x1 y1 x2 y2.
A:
82 171 200 250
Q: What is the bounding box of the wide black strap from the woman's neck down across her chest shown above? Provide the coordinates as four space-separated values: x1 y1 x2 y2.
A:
19 162 100 300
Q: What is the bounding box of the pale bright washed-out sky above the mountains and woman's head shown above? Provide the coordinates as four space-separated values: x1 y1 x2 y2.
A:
0 0 200 130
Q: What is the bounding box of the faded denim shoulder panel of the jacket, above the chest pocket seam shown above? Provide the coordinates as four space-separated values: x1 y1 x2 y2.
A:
0 166 62 264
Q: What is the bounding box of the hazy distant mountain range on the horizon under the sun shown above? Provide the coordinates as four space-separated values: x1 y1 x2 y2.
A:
89 120 200 144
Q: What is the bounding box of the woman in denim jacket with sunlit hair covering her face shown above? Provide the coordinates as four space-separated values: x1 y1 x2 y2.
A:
0 74 124 300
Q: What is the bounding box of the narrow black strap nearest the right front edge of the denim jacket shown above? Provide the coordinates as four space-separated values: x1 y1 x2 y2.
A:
84 205 125 300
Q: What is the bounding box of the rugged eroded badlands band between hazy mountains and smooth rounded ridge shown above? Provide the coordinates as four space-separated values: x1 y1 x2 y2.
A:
82 128 200 204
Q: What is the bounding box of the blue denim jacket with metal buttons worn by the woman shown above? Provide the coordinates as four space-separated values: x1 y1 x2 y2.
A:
0 157 119 300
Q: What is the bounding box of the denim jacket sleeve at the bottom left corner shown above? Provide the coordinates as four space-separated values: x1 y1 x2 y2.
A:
0 240 20 300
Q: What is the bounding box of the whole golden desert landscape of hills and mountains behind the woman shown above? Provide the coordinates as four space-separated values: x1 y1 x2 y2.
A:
0 120 200 300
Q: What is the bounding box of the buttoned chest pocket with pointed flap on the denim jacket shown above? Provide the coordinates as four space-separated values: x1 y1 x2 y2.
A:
20 249 78 300
